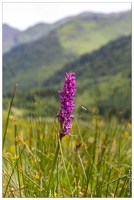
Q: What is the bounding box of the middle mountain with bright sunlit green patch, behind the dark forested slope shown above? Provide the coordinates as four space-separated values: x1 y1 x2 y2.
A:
3 12 131 93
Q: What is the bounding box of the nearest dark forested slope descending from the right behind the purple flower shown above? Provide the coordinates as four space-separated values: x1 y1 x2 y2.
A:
43 36 132 116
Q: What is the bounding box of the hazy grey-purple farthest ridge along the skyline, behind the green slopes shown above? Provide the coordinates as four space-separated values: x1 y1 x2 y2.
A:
2 11 131 53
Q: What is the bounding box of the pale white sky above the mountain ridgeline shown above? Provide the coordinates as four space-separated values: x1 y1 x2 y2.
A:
2 2 131 30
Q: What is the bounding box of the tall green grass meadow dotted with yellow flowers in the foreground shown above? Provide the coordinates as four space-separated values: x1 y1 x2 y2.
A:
2 84 132 198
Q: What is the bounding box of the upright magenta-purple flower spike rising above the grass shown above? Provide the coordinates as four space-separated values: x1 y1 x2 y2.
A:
57 72 76 138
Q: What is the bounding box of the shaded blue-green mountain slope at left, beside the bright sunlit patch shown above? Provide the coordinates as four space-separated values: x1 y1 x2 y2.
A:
3 32 76 93
